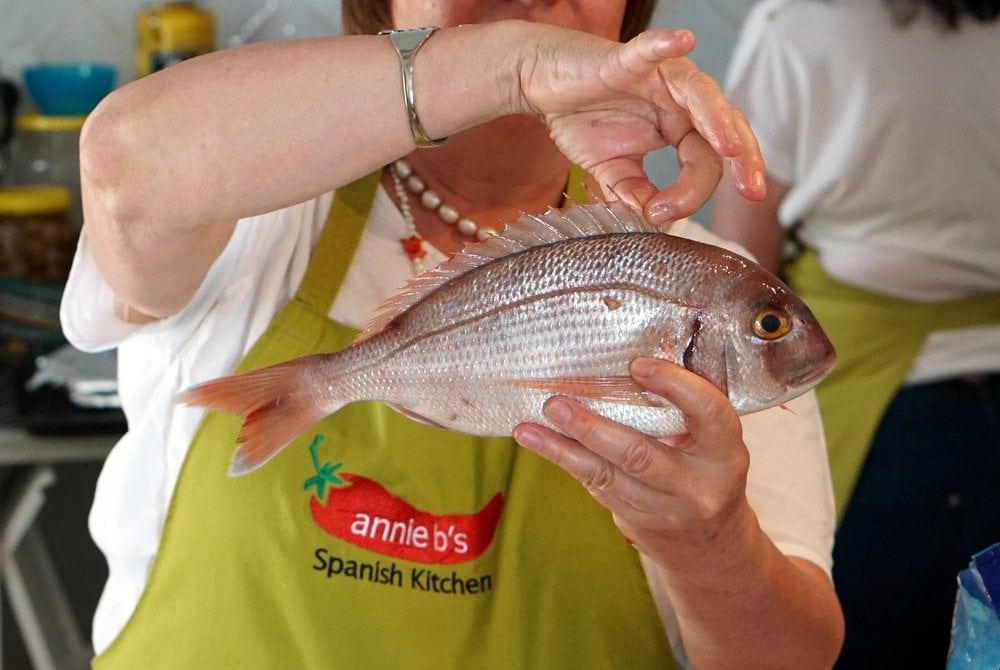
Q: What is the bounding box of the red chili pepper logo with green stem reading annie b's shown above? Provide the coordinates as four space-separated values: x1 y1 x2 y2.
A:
306 435 504 564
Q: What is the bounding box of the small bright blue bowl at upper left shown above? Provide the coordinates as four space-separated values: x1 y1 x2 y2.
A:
23 63 117 116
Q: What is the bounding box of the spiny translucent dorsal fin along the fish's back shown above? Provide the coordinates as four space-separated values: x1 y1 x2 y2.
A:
354 199 661 344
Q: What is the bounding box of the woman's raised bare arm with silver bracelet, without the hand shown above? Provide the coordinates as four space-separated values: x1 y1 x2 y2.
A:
81 22 537 316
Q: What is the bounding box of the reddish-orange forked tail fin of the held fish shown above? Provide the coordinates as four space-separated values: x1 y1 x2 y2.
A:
181 357 338 477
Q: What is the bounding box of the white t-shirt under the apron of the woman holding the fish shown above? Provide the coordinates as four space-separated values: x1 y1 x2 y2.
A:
62 188 834 664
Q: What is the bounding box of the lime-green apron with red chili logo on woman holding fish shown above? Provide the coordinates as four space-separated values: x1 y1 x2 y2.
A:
94 173 673 670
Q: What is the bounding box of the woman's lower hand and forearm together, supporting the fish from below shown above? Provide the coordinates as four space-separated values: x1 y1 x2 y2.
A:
514 359 843 670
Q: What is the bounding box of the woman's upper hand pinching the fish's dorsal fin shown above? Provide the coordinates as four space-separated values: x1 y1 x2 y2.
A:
520 28 765 223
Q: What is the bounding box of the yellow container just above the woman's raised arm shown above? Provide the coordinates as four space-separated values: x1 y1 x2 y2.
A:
135 2 215 77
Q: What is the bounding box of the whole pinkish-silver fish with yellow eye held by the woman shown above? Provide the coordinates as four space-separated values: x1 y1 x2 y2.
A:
181 200 836 476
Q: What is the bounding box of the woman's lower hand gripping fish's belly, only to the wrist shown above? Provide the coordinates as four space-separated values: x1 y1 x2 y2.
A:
514 359 749 565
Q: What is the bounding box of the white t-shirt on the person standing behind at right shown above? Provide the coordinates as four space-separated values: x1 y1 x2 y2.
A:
726 0 1000 383
